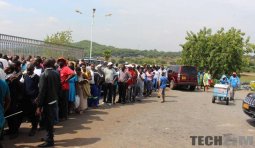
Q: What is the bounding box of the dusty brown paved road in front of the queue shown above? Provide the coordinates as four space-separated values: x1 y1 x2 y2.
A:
3 88 255 148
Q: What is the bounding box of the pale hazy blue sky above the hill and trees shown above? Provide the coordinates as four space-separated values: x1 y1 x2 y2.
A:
0 0 255 51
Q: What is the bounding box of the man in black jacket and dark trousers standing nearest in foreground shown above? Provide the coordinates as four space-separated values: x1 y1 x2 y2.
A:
36 59 61 147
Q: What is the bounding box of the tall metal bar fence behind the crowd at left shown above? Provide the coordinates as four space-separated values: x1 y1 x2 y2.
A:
0 34 85 59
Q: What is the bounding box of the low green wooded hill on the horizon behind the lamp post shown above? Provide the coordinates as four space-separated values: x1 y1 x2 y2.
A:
73 40 181 58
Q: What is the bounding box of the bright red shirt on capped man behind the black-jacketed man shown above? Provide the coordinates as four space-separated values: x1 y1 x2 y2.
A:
60 66 74 90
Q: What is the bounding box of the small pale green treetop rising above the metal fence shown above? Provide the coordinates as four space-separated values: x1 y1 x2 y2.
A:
45 30 73 45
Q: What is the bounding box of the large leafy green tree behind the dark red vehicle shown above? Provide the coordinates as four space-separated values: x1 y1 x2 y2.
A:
181 28 254 78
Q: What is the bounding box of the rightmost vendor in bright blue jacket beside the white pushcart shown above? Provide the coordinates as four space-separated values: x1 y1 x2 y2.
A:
229 72 240 100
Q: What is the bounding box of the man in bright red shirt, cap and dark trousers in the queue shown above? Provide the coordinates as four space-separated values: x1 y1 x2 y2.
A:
57 58 75 121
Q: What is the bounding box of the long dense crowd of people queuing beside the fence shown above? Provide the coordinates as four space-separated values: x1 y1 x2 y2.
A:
0 54 168 147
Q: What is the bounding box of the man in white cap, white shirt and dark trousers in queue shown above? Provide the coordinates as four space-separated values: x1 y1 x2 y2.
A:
103 62 116 105
